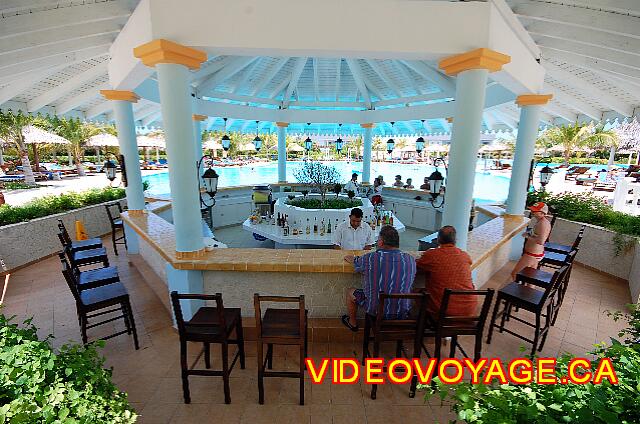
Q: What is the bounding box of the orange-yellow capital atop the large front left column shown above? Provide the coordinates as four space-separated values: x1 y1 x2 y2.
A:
133 38 207 69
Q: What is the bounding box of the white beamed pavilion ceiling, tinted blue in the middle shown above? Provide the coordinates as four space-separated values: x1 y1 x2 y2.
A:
0 0 640 134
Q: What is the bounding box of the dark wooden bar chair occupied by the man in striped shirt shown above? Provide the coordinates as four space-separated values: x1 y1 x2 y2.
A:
362 292 428 399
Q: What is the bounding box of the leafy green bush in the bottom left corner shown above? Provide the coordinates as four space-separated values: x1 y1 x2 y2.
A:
0 314 137 424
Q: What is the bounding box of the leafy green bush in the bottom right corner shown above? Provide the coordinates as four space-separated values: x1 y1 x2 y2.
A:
422 306 640 424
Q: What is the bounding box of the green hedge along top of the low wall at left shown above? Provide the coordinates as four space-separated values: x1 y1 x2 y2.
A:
0 187 125 227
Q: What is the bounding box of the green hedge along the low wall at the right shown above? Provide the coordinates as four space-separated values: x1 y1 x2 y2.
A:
527 191 640 237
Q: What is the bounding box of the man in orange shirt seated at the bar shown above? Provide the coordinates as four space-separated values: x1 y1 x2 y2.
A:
416 225 477 318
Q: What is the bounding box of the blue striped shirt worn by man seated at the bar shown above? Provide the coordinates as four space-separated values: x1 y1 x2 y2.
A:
353 249 416 318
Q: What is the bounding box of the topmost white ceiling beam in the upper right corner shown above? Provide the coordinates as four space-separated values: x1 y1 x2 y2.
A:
513 2 640 38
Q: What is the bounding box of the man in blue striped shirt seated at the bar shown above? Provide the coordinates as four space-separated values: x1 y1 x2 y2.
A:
342 225 416 331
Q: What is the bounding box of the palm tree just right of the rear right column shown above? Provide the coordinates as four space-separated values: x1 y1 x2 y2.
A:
542 122 612 165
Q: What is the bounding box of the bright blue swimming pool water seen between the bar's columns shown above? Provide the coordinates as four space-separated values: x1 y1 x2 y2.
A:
143 161 509 203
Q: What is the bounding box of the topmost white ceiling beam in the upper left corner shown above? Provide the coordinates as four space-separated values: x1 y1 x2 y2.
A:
0 0 136 38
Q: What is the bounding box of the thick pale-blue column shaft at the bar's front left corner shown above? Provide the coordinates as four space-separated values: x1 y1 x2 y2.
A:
156 63 204 252
